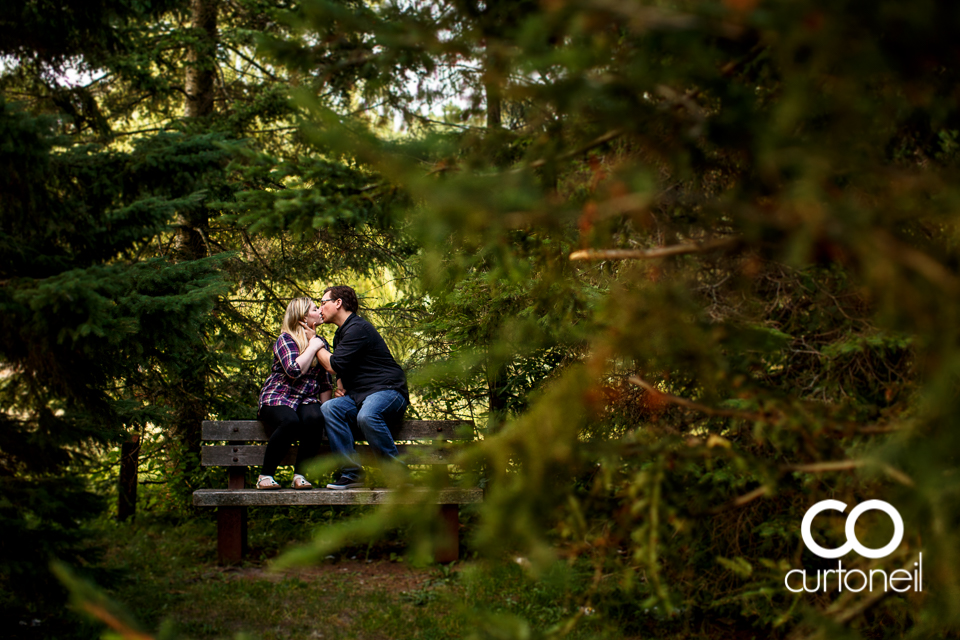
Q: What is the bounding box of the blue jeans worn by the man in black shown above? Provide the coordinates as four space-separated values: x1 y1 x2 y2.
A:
320 389 407 480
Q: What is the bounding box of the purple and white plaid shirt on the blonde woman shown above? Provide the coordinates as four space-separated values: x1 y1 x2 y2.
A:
260 333 333 410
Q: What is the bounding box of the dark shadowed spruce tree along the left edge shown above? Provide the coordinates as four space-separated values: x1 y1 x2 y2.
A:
0 102 231 616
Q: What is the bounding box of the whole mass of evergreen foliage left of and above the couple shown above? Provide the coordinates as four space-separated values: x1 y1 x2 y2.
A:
0 0 413 619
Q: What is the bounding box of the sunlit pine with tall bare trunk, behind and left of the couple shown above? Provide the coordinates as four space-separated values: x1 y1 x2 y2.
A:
5 0 411 496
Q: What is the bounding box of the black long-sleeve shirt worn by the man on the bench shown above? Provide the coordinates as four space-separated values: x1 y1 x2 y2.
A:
330 313 410 407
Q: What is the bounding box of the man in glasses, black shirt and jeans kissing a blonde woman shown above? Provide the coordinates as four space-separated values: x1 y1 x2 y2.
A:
317 285 410 489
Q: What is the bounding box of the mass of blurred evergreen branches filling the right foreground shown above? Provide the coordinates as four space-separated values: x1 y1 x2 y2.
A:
262 0 960 637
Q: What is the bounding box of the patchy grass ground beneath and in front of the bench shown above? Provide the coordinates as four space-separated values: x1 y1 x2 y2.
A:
60 508 623 640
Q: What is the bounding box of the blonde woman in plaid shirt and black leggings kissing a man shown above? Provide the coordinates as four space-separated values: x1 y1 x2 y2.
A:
257 298 333 489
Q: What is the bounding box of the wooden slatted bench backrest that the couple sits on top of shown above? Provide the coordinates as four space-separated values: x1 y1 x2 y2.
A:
200 420 474 467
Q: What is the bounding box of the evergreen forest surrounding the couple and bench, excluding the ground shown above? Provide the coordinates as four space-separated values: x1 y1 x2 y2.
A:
0 0 960 638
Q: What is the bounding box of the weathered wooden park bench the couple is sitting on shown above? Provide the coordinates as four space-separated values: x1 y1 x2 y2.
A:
193 420 483 564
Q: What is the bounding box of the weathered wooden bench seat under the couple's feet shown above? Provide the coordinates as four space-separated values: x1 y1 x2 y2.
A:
193 487 483 507
